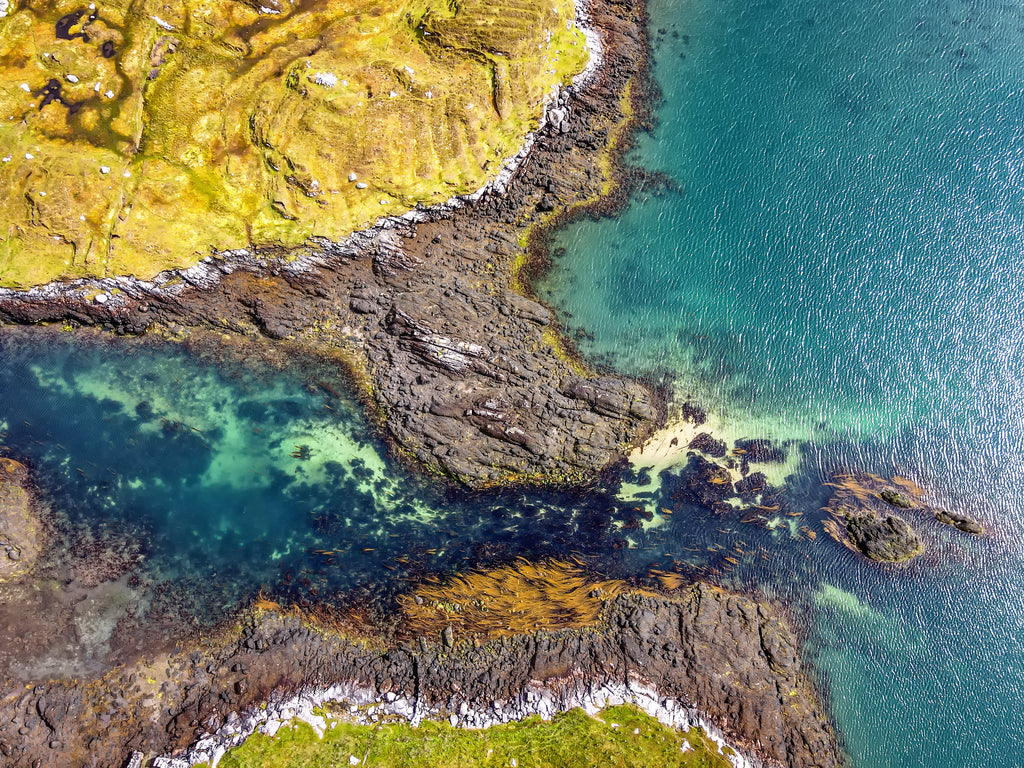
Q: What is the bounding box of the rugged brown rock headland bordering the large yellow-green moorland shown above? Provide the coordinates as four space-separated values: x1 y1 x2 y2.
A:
0 0 657 486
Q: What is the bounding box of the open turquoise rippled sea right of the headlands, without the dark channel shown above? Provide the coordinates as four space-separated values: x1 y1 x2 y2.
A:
542 0 1024 768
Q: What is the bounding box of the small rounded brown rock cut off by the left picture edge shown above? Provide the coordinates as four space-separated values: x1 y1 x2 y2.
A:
0 458 41 582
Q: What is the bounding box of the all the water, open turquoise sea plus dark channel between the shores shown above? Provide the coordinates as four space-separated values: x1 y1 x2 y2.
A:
0 0 1024 768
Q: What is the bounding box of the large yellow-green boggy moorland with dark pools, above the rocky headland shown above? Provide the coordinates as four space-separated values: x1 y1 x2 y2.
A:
0 0 588 287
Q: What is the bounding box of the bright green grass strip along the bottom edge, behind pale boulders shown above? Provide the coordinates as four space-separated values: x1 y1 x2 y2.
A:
219 707 731 768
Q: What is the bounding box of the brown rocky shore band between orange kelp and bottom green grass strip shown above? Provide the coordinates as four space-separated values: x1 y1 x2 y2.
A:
0 584 844 768
